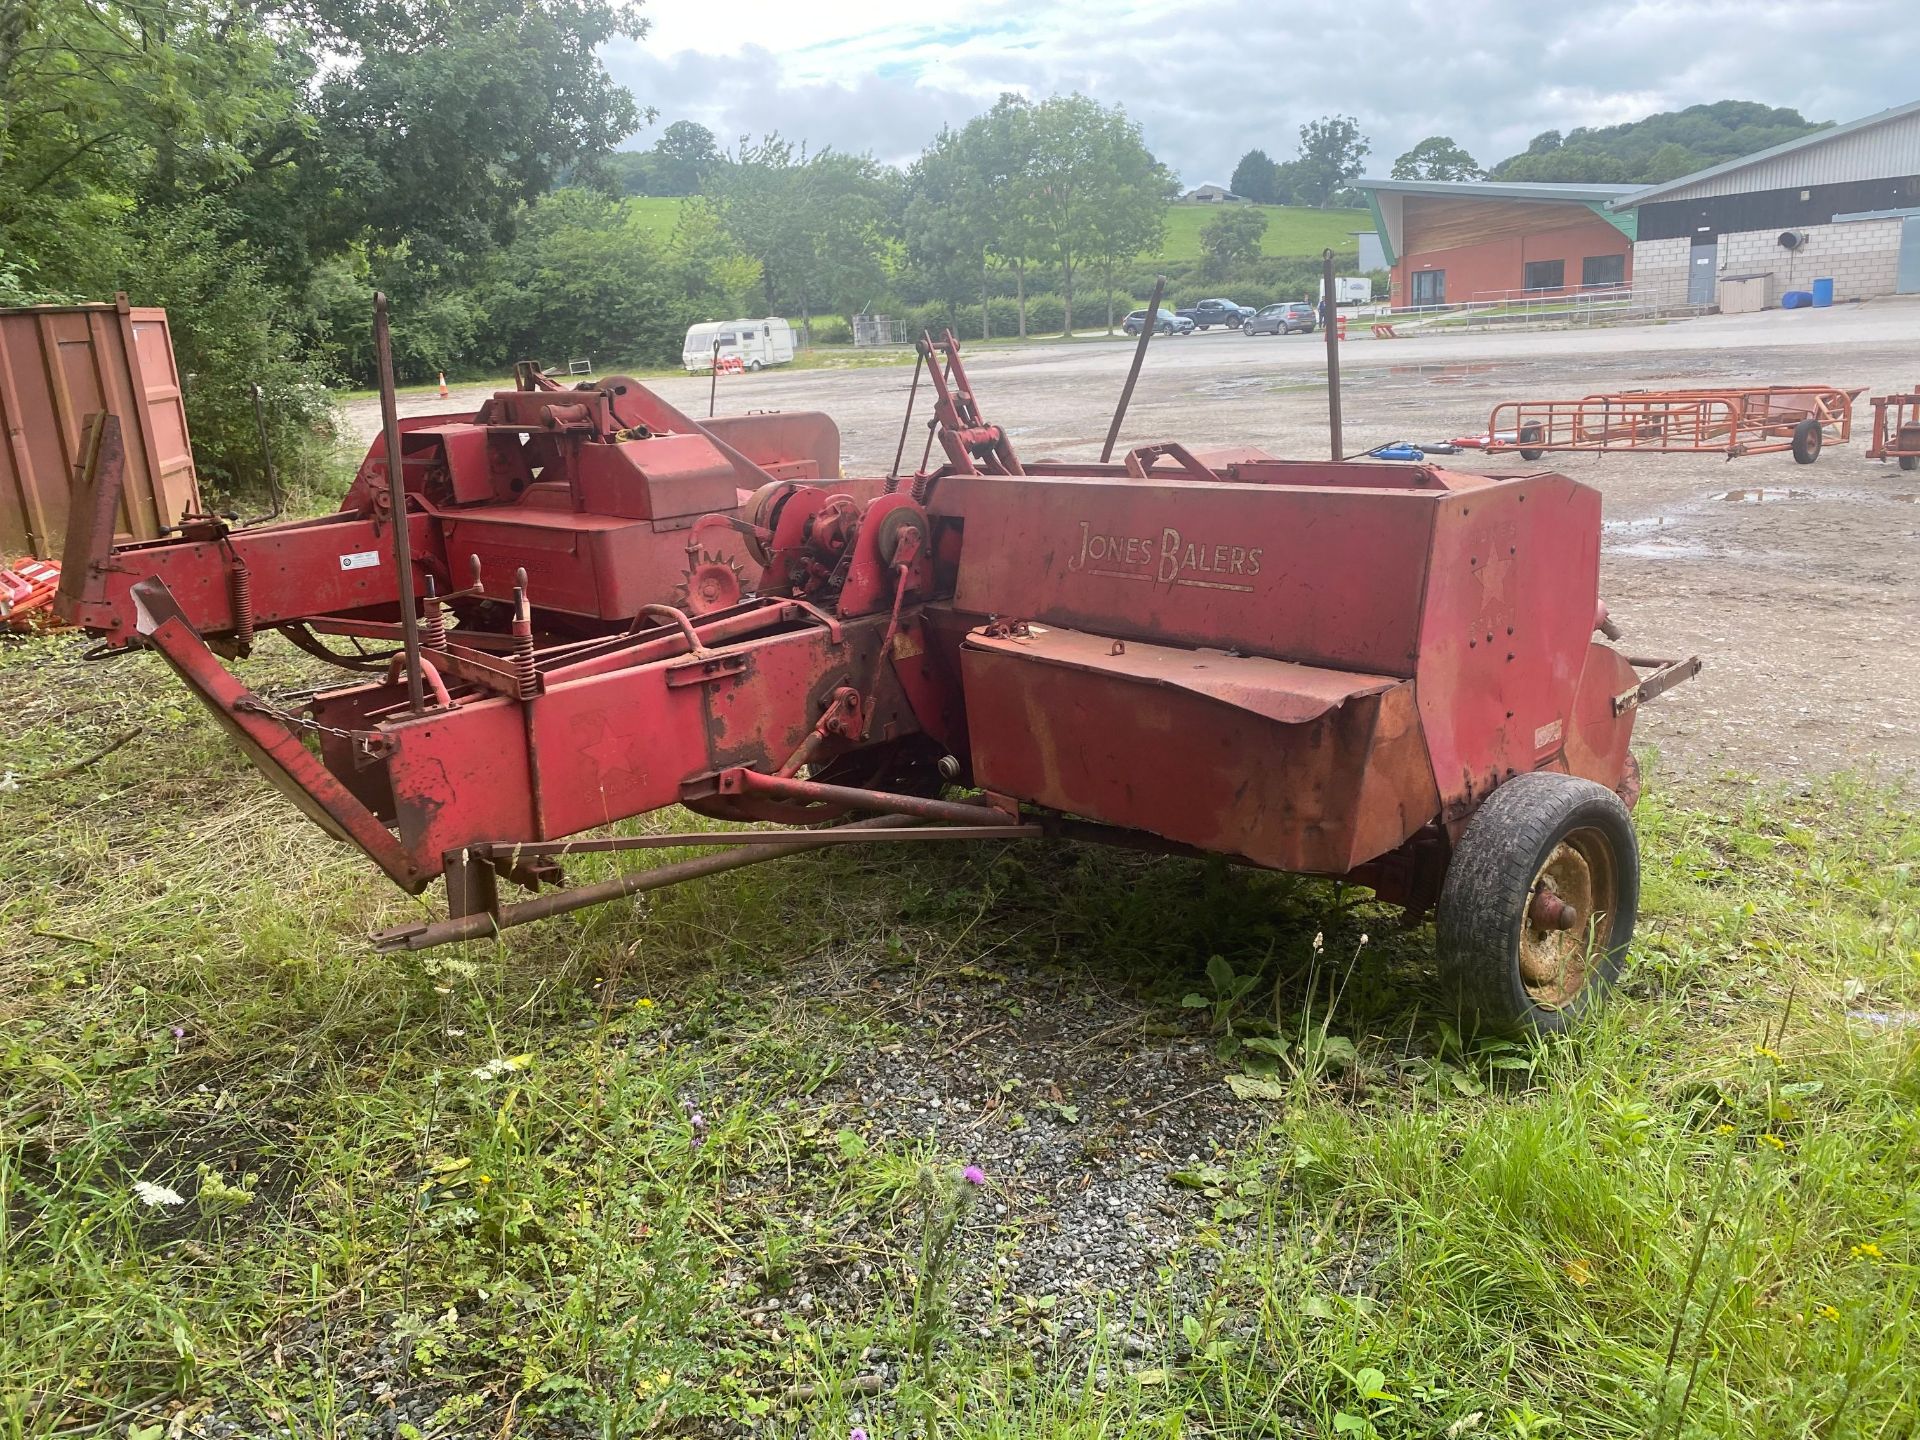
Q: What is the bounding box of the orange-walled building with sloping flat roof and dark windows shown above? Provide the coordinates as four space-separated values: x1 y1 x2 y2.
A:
1354 180 1636 309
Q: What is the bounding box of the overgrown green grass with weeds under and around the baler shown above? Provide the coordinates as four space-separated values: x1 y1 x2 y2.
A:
0 639 1920 1440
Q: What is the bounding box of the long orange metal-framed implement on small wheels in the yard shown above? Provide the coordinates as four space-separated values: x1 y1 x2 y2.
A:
1482 386 1864 465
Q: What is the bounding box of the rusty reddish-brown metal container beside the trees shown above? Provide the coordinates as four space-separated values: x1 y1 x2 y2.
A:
0 294 200 559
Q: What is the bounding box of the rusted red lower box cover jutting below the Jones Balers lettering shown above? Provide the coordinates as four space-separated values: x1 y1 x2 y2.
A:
960 626 1438 874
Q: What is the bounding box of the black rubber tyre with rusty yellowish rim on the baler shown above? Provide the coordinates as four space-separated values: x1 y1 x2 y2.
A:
1436 770 1640 1035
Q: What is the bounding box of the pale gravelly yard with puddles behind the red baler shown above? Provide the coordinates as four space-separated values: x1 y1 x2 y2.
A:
348 300 1920 781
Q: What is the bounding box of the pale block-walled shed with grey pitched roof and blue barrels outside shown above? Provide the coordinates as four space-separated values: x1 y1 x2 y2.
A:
1613 102 1920 307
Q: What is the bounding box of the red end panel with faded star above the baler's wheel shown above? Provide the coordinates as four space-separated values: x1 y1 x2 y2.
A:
1419 474 1599 820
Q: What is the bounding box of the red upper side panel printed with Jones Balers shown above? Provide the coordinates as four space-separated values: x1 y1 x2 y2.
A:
929 476 1446 676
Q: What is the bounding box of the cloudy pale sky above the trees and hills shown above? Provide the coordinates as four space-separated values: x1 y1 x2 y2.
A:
605 0 1920 184
